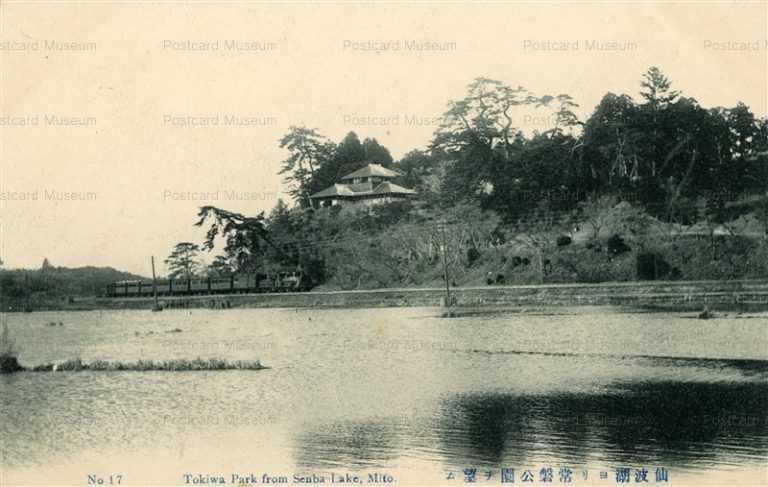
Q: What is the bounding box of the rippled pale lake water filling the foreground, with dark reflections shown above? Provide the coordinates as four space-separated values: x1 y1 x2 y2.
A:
0 308 768 485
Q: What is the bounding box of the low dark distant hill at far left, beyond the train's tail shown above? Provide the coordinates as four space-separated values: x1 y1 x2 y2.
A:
0 266 146 310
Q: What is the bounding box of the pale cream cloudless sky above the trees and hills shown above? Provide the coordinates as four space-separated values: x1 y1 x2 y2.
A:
0 1 768 275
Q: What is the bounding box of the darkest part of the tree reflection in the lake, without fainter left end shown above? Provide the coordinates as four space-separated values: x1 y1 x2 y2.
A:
440 382 768 466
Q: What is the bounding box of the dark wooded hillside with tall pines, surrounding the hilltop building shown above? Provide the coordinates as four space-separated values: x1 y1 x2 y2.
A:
166 68 768 288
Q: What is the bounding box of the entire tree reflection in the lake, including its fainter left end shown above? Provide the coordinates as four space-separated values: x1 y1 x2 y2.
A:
294 381 768 470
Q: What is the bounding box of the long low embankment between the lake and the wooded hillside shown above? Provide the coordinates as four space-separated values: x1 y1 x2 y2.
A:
16 280 768 311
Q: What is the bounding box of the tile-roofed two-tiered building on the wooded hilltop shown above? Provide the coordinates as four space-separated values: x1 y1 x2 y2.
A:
310 164 416 207
